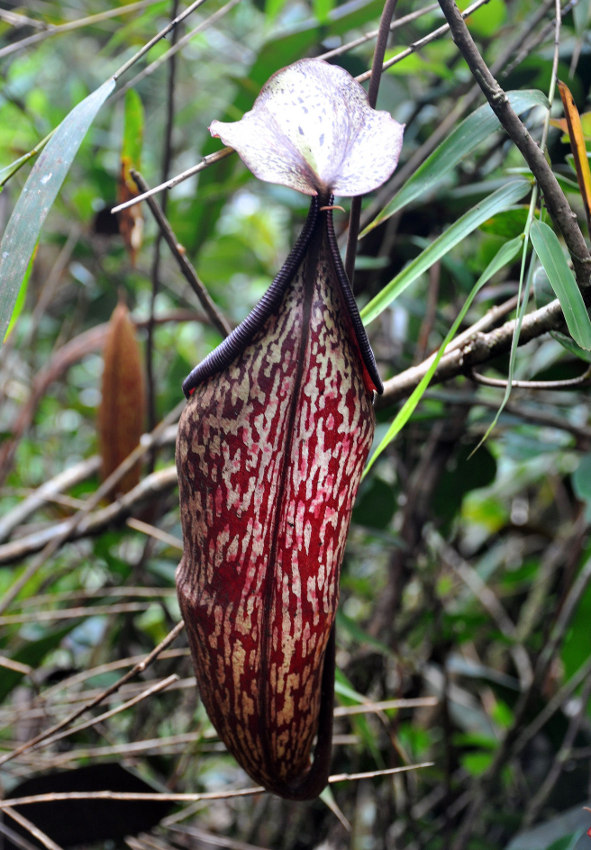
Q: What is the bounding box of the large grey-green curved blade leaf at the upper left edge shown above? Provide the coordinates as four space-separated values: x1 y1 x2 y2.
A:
0 79 115 338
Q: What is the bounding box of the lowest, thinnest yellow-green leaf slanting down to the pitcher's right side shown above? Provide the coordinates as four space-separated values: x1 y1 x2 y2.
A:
363 236 523 476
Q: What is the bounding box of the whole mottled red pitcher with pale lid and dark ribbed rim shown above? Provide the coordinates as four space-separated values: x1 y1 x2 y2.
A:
177 60 402 799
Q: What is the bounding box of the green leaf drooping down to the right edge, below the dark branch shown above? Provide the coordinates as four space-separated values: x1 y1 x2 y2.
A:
531 219 591 351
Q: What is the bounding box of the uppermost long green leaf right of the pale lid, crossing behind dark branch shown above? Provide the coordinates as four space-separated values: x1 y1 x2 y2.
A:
361 89 548 236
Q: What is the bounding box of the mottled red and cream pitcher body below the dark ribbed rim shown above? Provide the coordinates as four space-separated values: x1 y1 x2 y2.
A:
177 213 374 790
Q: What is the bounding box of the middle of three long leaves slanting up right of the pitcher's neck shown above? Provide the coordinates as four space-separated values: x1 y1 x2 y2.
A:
361 179 530 324
